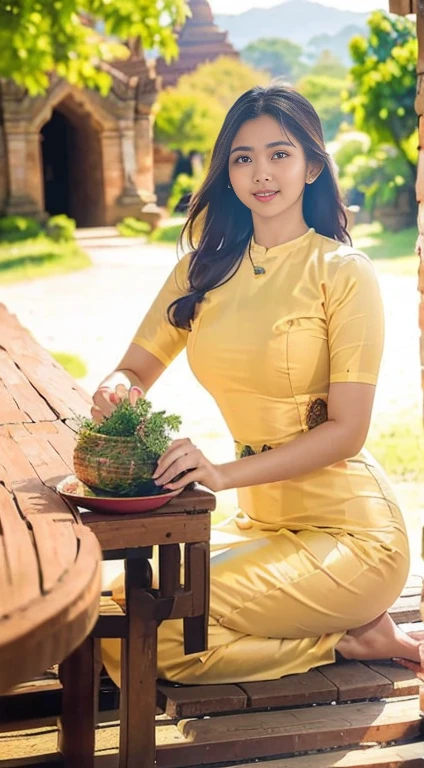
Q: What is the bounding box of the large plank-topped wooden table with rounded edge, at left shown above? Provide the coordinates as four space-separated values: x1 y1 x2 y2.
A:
0 305 101 692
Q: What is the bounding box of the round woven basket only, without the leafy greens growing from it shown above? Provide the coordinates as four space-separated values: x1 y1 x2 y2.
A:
74 433 156 496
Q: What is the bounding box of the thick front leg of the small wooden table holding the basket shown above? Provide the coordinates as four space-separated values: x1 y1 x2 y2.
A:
119 558 157 768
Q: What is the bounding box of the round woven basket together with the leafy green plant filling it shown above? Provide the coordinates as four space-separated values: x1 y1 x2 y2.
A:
74 398 181 496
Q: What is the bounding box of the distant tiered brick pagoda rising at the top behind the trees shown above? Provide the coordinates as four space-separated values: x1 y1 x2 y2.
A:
156 0 239 88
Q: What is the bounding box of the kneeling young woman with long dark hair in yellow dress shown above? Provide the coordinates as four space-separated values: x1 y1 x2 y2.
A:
96 85 423 683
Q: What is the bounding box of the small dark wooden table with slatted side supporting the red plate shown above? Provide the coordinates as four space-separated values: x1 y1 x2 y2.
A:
60 490 215 768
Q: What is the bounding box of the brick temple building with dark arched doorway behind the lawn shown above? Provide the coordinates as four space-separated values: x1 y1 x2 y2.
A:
0 52 160 227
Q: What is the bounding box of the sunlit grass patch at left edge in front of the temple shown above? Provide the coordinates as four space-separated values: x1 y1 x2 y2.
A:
0 235 91 285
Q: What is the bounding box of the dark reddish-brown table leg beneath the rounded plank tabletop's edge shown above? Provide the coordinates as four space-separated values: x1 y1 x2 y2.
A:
58 637 101 768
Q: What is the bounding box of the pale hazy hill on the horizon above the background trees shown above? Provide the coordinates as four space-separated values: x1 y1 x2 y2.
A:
215 0 372 50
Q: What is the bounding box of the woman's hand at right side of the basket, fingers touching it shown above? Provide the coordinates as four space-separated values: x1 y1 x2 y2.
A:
153 438 224 491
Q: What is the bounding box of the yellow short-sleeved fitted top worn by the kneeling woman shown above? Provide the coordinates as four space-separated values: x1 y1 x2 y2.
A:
134 229 384 522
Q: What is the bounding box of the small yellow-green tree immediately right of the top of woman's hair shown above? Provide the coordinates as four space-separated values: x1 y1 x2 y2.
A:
296 74 346 141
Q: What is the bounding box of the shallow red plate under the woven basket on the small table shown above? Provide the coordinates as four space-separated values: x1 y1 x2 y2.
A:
56 475 182 515
